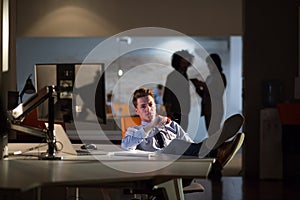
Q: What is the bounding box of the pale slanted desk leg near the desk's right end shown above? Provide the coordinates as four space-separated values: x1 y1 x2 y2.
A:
154 178 184 200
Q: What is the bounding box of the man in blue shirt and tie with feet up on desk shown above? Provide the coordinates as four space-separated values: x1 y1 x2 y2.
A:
121 88 244 166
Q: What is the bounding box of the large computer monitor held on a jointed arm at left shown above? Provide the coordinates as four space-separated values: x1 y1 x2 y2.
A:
34 63 106 124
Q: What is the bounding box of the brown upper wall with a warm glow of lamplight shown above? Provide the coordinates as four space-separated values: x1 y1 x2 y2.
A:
17 0 242 37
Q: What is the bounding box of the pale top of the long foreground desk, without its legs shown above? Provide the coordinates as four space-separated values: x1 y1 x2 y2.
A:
0 160 212 191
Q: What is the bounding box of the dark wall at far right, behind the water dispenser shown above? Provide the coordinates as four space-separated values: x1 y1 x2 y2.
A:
243 0 299 179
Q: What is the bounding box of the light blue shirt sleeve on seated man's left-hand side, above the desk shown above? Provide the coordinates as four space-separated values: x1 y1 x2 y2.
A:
121 126 146 150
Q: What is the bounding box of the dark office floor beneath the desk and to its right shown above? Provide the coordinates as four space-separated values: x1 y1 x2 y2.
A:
66 176 300 200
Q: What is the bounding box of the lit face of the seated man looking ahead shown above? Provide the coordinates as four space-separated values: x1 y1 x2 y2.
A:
135 95 156 122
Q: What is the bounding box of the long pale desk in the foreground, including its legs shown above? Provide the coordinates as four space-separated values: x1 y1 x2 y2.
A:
0 145 214 200
